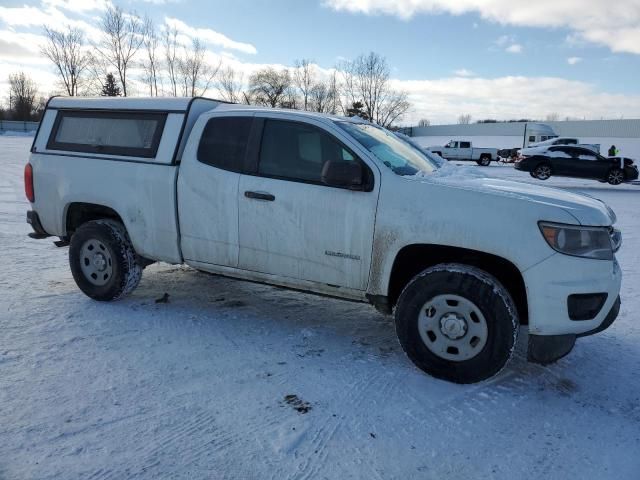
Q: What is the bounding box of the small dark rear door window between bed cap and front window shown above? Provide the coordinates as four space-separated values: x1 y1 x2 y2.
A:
198 117 253 172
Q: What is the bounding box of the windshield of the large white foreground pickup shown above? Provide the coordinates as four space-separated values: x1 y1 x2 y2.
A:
336 122 439 176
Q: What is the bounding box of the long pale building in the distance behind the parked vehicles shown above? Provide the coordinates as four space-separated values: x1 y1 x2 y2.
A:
410 119 640 160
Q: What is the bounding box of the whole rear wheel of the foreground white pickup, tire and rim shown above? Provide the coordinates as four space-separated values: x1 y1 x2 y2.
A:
69 220 142 301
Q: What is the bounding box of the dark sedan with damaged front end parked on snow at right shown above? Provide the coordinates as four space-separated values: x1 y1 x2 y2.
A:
515 145 638 185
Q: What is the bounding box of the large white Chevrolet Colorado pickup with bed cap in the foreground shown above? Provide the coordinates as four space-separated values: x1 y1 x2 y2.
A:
25 98 621 383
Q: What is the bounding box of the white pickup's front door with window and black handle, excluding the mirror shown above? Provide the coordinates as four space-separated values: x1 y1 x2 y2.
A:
238 115 378 290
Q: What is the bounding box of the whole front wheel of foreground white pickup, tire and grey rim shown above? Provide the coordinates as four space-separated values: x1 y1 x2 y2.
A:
395 264 519 383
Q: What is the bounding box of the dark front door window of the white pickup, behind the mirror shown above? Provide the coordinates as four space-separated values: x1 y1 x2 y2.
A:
258 120 356 183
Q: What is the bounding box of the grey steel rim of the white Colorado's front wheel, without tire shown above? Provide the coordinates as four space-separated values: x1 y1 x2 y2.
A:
418 294 488 362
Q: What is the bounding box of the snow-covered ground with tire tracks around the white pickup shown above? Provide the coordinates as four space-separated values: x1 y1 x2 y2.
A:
0 136 640 480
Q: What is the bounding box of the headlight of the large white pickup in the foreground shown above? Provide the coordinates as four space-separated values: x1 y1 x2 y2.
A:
538 222 622 260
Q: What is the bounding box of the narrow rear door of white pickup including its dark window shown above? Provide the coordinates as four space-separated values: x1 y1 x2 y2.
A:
178 112 253 267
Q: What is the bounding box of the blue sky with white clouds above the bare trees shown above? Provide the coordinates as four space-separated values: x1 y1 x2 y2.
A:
0 0 640 123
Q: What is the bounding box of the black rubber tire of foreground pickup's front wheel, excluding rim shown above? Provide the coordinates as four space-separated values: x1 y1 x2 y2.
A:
395 264 519 383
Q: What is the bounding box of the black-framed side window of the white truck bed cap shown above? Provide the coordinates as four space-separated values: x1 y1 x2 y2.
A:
47 111 167 158
